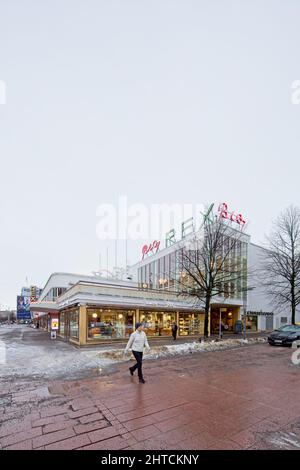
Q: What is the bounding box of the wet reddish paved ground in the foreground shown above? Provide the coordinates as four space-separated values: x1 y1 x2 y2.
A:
0 344 300 450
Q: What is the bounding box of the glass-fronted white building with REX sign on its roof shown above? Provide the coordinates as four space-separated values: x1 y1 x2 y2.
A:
31 209 289 346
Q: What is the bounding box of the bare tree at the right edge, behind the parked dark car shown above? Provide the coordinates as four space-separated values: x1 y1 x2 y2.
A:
262 206 300 324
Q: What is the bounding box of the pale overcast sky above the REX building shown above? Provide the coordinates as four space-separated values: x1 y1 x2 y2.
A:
0 0 300 308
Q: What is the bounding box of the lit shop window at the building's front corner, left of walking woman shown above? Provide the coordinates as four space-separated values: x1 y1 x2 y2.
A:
87 308 135 339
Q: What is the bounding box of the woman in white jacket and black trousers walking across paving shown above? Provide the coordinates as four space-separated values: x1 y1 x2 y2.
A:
124 323 150 384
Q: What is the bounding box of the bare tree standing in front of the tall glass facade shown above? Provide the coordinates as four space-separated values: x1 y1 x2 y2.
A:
177 217 247 337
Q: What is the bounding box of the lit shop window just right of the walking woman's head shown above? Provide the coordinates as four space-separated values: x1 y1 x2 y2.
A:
140 310 176 336
